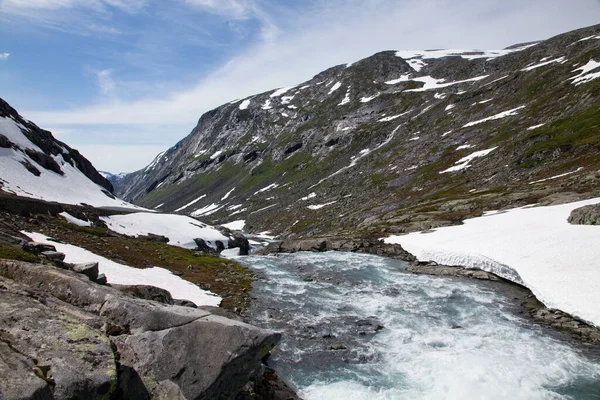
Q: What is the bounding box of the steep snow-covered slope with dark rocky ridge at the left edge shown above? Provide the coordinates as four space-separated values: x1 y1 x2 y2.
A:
0 99 139 208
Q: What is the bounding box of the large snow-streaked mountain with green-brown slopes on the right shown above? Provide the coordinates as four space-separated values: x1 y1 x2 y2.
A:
116 25 600 237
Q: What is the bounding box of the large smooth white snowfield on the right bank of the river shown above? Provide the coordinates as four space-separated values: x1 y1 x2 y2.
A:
385 198 600 326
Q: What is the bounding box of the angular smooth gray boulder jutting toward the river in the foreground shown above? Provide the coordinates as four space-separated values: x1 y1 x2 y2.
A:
113 315 279 399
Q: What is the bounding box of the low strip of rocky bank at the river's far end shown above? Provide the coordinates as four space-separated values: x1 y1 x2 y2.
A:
254 238 415 261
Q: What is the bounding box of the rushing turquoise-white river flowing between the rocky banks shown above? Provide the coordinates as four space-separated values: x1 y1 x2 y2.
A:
240 252 600 400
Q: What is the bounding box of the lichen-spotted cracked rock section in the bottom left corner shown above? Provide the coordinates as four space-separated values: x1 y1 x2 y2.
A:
0 277 117 399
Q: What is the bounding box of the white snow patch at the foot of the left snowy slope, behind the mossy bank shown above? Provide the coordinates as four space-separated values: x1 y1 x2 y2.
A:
101 213 228 249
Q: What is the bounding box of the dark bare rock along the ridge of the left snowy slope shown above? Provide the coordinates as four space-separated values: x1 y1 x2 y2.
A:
0 99 113 192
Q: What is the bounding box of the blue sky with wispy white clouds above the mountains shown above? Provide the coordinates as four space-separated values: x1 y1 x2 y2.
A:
0 0 600 173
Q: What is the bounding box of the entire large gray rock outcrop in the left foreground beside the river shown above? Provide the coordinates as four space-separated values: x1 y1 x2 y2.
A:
0 260 279 399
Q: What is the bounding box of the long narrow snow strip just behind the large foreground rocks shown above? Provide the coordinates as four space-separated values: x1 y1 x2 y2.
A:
23 232 221 307
